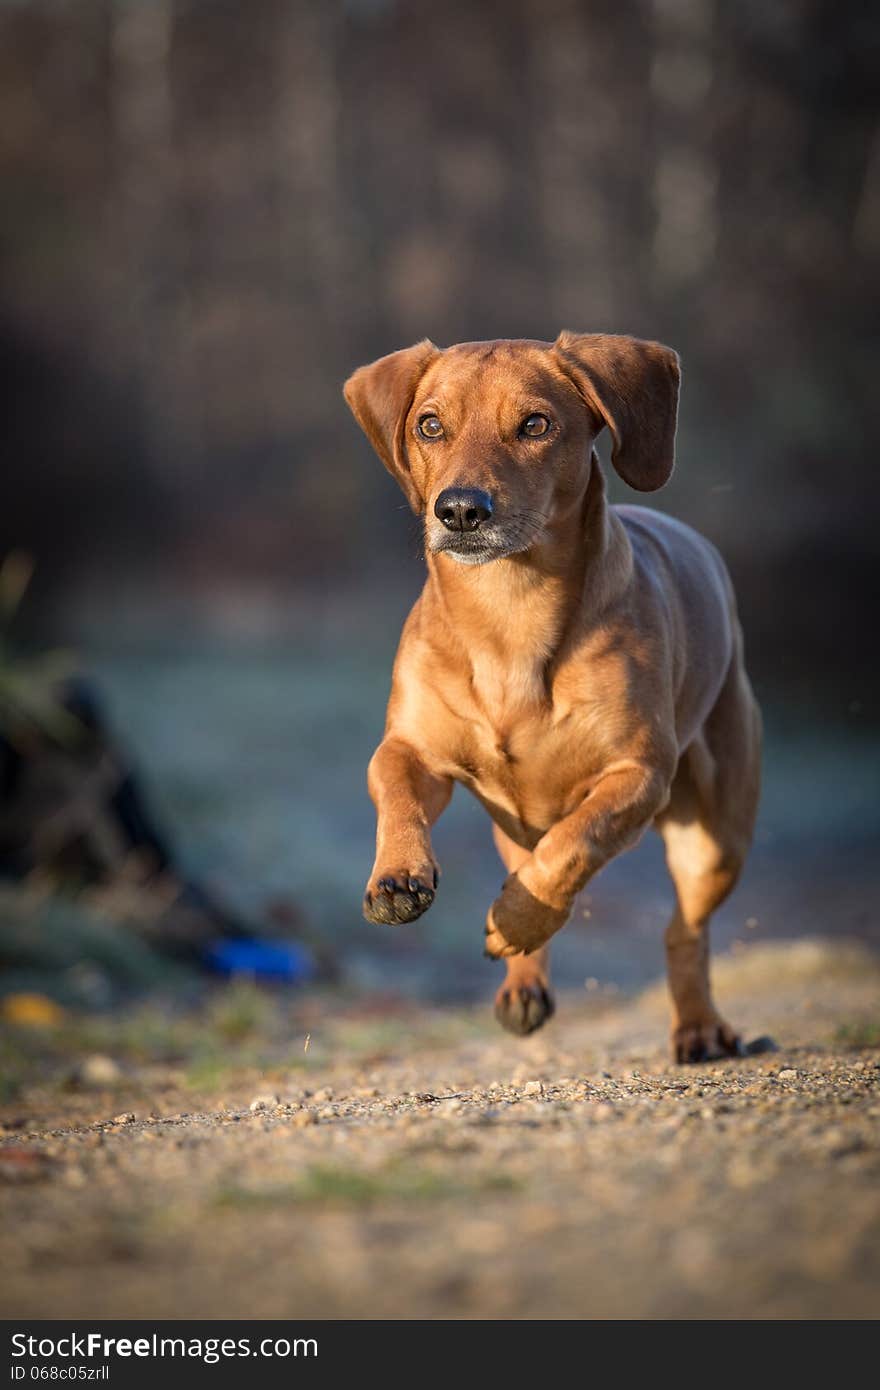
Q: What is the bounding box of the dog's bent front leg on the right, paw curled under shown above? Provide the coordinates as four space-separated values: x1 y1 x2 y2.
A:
485 762 671 958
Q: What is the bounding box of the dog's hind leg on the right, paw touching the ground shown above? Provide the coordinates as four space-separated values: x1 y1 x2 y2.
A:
656 644 760 1062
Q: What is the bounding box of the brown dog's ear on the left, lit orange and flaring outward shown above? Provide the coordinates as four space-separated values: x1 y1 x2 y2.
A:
342 338 439 513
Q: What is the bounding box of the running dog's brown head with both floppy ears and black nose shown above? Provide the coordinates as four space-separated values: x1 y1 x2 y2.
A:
345 332 680 564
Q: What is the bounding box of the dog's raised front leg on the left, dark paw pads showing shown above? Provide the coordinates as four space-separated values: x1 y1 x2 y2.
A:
364 737 452 924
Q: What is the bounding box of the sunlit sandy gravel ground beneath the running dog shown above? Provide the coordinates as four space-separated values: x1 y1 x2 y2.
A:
0 941 880 1319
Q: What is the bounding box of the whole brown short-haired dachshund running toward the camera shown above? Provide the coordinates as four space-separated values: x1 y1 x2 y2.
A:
345 332 760 1061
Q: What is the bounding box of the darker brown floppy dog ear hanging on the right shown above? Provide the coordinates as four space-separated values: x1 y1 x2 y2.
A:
553 332 681 492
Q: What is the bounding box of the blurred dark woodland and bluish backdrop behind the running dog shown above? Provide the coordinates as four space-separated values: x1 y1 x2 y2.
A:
0 0 880 1012
